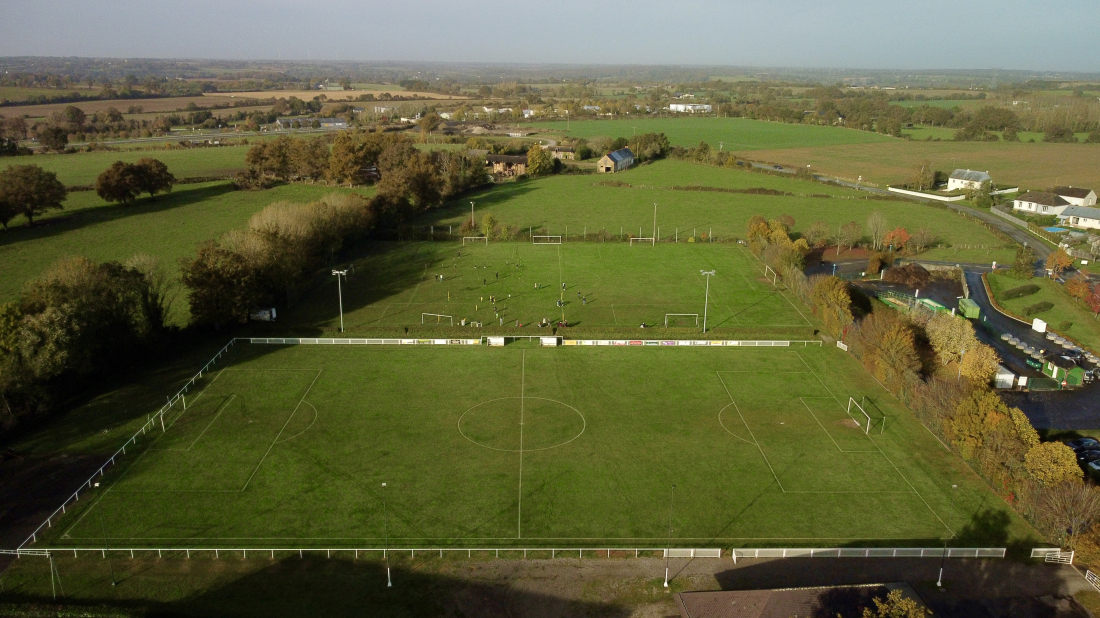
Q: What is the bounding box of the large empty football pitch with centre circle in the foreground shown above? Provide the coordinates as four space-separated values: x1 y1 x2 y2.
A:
40 341 991 549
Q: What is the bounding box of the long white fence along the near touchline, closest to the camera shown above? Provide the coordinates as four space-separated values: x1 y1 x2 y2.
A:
0 548 1007 562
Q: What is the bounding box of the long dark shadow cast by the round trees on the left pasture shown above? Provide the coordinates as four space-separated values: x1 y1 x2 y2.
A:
0 183 235 245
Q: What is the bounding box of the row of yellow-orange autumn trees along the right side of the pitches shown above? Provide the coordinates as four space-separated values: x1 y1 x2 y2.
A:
748 211 1100 547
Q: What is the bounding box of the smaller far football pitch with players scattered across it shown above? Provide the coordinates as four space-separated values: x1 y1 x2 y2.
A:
288 242 814 339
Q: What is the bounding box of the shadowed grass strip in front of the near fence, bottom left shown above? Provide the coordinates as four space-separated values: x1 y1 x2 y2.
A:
0 555 630 618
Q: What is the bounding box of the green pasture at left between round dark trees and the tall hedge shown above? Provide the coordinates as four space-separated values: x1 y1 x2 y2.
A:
0 180 369 323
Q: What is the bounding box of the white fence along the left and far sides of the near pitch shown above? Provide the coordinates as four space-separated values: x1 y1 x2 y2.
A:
18 338 822 551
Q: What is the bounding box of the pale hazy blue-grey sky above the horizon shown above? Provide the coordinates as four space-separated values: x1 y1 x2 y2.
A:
0 0 1100 71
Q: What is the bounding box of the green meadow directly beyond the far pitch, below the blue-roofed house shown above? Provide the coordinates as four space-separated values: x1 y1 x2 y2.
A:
420 161 1014 263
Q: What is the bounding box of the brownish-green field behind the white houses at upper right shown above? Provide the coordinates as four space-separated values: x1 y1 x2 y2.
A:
746 139 1100 189
